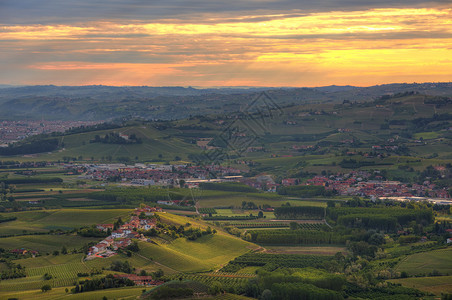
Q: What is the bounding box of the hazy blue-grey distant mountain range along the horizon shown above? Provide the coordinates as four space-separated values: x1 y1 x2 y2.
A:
0 83 452 120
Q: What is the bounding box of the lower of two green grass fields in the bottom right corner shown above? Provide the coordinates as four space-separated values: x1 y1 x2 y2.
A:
389 276 452 295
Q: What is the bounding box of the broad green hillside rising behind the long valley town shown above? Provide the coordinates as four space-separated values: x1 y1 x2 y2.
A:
5 92 452 180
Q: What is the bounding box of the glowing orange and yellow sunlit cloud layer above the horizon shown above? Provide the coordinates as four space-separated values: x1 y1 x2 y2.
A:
0 8 452 86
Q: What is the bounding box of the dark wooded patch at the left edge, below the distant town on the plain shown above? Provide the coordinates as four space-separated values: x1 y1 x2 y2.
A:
0 138 59 155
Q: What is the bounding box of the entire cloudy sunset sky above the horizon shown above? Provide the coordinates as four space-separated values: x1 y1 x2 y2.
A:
0 0 452 87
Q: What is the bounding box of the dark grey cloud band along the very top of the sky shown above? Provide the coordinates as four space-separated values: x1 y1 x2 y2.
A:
0 0 452 24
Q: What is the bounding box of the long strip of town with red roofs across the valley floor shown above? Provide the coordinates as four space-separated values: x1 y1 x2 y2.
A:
65 164 451 204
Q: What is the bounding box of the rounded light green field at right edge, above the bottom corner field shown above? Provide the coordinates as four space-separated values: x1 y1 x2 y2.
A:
396 247 452 275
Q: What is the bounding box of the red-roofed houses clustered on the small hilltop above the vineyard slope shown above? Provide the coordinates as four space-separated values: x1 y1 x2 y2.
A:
88 206 162 258
